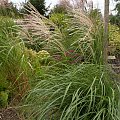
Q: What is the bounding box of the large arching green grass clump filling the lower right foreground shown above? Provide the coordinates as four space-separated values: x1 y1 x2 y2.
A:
23 64 119 120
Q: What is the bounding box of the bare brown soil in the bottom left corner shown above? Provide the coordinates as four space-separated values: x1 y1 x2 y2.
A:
0 108 21 120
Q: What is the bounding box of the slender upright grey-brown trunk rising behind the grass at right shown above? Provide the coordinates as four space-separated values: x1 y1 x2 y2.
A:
103 0 109 64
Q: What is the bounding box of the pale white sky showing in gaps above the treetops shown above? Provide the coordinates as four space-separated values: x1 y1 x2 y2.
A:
11 0 115 13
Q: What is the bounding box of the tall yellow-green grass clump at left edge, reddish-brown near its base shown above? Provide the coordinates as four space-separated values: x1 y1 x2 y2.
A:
0 17 31 104
